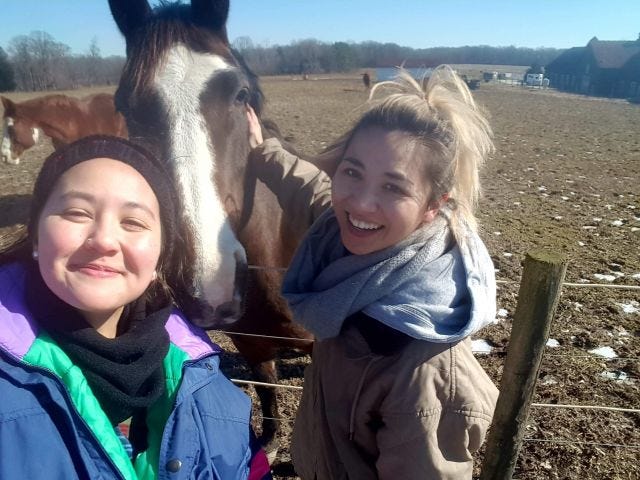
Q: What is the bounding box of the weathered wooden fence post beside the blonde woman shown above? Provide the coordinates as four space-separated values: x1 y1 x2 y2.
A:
480 250 567 480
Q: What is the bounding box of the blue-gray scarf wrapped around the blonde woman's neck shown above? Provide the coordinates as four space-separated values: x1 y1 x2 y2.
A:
282 209 456 340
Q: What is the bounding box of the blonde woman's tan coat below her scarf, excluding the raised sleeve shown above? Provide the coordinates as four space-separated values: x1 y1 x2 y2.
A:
291 327 498 480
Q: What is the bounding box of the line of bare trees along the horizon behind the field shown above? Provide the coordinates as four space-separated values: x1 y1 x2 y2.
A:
0 31 563 91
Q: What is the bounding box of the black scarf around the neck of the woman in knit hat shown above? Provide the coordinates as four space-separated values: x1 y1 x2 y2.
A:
27 266 171 451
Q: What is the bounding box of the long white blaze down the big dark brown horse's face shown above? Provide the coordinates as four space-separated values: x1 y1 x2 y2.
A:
154 46 246 316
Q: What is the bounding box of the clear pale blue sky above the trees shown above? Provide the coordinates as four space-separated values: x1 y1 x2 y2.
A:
0 0 640 55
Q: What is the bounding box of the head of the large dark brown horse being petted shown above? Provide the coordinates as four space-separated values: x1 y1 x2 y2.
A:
109 0 262 327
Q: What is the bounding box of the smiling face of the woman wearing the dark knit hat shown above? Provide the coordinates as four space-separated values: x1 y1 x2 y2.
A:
35 158 161 336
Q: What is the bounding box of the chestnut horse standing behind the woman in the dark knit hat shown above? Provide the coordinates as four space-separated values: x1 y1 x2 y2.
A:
0 93 127 165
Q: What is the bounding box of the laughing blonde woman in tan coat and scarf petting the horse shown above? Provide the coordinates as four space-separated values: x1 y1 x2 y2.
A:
249 67 498 480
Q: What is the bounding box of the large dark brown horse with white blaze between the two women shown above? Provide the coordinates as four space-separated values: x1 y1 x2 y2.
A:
109 0 312 457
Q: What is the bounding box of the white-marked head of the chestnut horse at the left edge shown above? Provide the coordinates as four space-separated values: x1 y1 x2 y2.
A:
0 97 39 165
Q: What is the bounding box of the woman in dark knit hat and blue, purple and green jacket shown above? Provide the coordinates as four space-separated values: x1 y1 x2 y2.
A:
0 136 271 480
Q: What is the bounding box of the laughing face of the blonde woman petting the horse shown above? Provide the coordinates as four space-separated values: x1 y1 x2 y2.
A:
331 128 439 255
